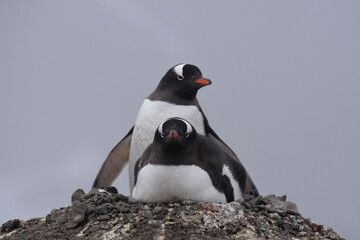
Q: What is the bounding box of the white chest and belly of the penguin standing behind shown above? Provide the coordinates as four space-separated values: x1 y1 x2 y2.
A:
129 99 205 195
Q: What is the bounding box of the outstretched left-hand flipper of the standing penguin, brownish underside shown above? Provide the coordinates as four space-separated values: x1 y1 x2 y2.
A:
92 127 134 188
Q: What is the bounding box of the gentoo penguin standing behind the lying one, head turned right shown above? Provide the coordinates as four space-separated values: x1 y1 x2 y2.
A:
93 63 257 196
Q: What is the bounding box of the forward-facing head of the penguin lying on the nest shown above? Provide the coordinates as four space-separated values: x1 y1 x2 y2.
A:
154 118 197 154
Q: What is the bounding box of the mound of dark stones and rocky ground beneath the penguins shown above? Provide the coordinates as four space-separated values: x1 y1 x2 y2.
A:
0 189 342 240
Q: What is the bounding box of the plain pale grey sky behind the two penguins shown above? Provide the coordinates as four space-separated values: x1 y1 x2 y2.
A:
0 0 360 239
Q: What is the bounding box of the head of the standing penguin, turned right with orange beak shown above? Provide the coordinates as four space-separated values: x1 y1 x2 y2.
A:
159 63 211 100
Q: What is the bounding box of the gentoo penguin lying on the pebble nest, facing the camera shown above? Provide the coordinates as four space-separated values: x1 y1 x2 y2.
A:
132 118 253 202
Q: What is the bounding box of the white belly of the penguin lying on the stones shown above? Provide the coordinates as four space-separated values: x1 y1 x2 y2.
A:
132 164 226 203
